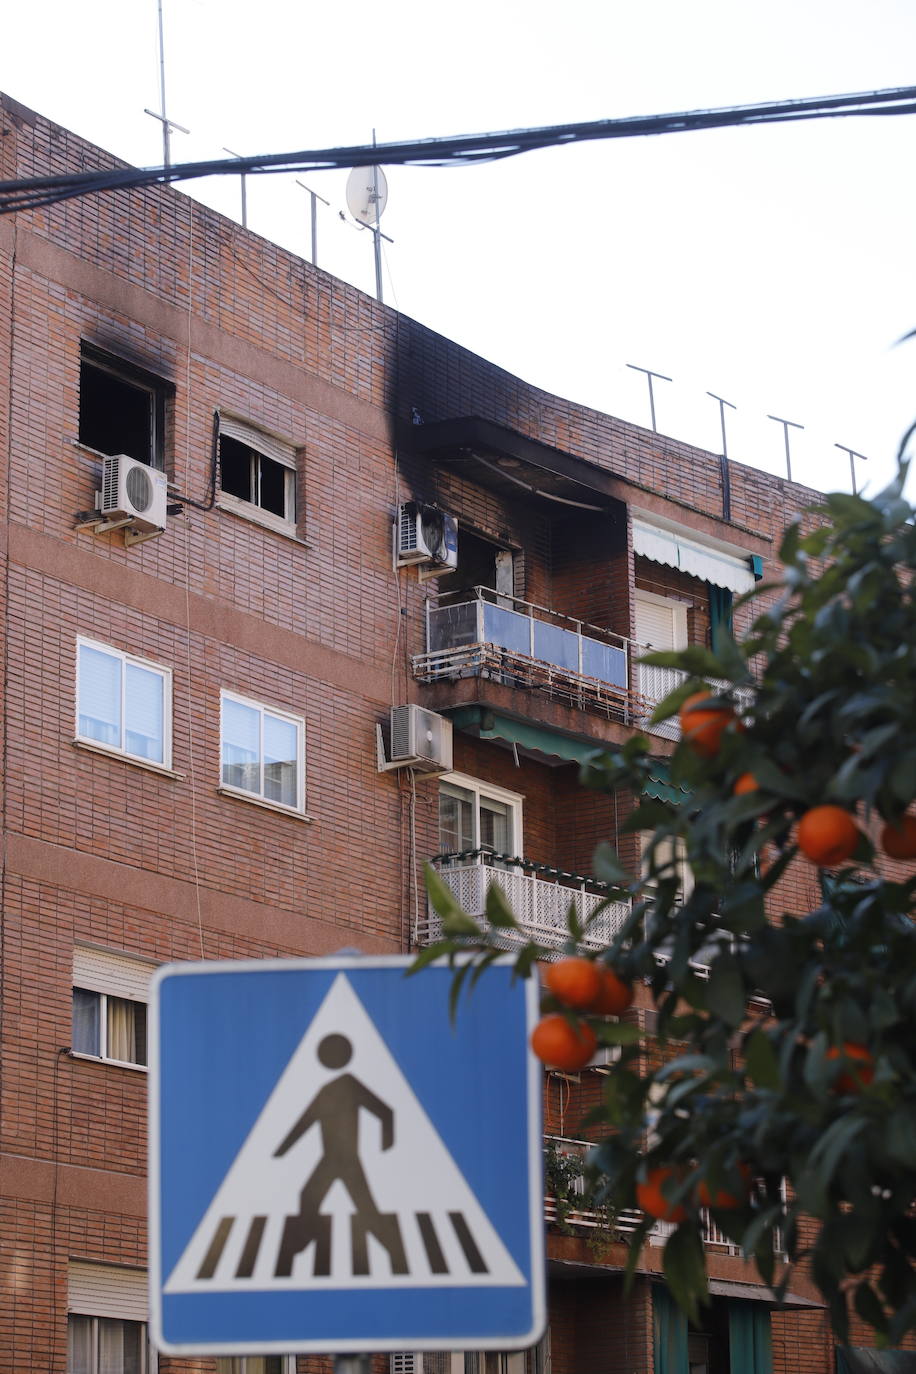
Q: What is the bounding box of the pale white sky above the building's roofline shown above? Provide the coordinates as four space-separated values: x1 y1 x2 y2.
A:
0 0 916 491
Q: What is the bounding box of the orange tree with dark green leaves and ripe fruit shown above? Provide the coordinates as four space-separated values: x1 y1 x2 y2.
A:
417 470 916 1344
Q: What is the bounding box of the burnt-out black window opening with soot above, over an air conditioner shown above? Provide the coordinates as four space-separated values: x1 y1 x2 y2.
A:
80 345 172 467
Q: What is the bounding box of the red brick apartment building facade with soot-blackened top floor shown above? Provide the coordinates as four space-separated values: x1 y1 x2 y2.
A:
0 91 900 1374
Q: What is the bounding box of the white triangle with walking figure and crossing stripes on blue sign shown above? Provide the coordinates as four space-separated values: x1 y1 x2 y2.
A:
165 973 526 1294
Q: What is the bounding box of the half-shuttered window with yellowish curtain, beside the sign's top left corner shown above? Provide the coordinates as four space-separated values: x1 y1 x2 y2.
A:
70 945 155 1068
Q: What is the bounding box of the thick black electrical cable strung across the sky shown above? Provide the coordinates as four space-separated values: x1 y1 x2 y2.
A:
0 87 916 214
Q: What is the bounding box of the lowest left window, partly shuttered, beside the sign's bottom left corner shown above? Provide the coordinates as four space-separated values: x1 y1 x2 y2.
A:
67 1260 157 1374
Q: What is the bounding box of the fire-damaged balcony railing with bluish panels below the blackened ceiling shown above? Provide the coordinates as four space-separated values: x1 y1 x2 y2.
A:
412 587 647 723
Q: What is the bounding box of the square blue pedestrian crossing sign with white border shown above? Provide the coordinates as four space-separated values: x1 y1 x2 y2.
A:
150 956 545 1355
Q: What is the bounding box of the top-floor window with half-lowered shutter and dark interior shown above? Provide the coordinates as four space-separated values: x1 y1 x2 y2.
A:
220 418 295 533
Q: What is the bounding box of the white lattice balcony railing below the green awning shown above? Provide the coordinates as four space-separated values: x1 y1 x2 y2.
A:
416 849 630 949
